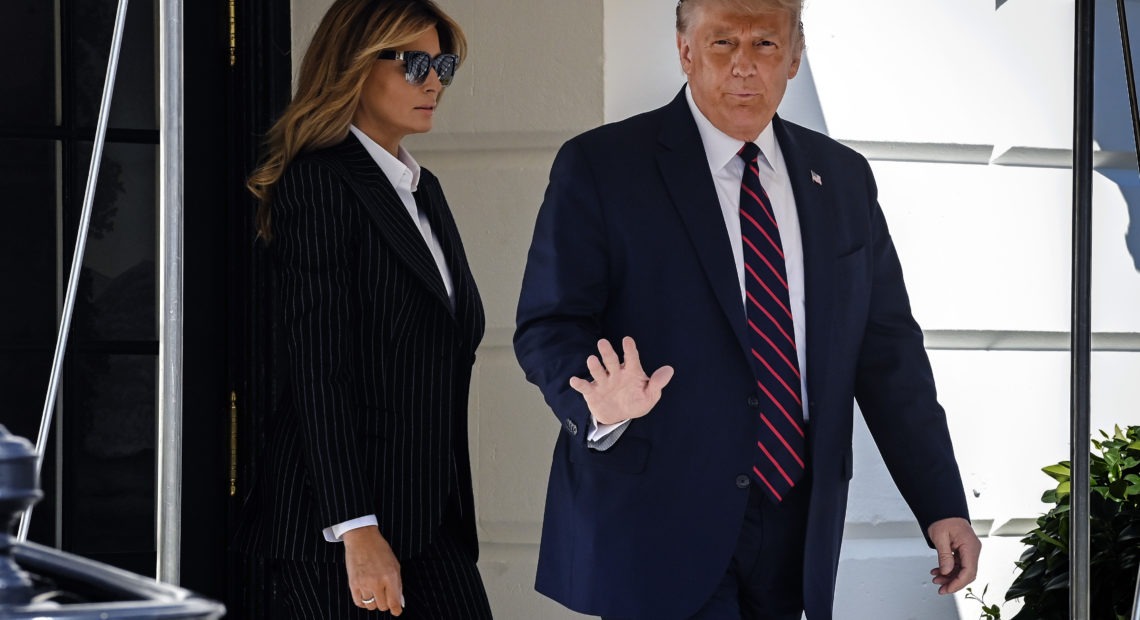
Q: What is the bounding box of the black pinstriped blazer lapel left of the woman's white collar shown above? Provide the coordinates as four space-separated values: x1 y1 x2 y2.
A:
333 133 454 316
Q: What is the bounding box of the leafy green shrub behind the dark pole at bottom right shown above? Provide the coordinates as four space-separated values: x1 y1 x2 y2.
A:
1005 426 1140 620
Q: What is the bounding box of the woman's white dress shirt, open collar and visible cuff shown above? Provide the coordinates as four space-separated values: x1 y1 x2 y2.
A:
324 125 455 543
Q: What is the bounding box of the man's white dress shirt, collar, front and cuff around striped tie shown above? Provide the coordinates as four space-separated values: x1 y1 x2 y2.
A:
586 87 808 447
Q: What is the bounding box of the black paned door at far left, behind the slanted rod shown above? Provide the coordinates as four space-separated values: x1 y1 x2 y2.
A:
0 0 165 574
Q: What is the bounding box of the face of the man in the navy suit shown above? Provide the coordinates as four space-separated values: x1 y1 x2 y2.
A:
677 1 801 141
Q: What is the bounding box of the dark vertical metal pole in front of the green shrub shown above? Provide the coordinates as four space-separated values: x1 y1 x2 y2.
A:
1069 0 1096 620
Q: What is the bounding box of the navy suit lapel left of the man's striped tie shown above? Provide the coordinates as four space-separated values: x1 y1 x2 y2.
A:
657 89 748 358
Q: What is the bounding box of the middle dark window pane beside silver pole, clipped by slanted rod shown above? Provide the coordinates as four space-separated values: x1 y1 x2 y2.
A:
64 142 157 340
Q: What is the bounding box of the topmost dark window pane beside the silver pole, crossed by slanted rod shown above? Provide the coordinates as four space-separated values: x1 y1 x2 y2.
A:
65 0 158 129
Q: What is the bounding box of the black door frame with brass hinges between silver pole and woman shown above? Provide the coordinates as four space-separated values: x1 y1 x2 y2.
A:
192 0 292 619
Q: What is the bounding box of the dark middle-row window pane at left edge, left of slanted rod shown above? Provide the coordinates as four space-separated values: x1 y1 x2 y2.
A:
0 139 57 346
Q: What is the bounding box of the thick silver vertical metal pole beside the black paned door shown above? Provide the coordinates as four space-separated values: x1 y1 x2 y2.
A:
155 0 182 585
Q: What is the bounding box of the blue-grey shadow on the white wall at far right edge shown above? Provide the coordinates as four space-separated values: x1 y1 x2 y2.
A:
1093 0 1140 271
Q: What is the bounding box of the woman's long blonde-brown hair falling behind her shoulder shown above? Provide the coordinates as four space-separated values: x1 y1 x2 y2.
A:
245 0 467 242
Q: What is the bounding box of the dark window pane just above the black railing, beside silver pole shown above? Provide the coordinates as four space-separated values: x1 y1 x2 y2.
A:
62 353 157 572
